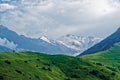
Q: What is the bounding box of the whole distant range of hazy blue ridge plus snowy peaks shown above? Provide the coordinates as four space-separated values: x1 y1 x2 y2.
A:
0 25 101 55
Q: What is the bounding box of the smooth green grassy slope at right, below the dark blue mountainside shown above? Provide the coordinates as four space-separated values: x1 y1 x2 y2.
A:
81 43 120 80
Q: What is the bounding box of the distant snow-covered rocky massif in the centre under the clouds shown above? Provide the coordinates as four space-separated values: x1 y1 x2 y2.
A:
58 34 102 53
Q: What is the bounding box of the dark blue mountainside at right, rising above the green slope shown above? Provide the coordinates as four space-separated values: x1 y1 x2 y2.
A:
80 28 120 56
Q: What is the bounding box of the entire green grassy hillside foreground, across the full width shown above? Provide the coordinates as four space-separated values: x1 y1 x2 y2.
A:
0 44 120 80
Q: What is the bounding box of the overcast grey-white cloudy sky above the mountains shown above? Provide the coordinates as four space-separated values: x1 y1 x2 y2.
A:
0 0 120 38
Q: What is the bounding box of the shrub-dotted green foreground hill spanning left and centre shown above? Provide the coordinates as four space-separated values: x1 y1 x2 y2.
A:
0 52 104 80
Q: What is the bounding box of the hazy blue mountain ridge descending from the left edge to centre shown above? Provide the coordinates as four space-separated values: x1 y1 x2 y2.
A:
0 25 77 54
